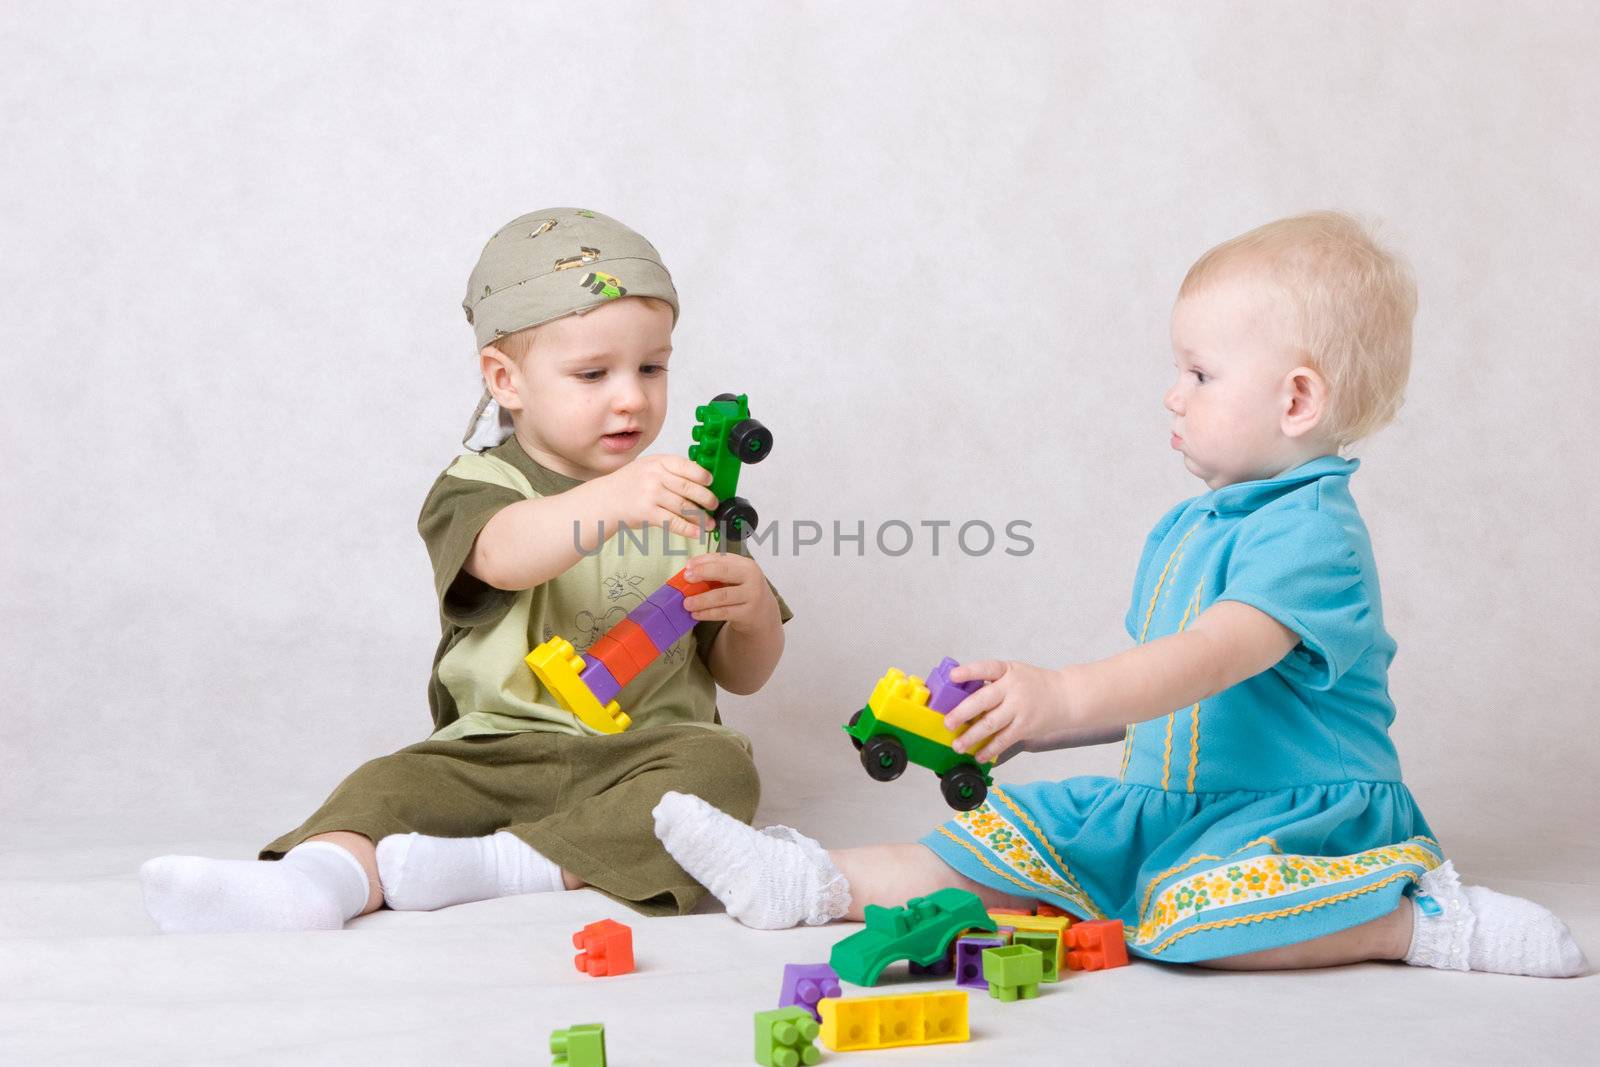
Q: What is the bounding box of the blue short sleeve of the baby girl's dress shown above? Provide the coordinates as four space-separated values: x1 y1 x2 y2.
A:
1218 510 1378 689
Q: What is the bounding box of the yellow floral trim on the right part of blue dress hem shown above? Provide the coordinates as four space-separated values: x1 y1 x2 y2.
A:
1134 837 1440 952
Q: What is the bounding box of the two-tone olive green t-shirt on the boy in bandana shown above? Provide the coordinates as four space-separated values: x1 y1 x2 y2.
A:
418 437 792 741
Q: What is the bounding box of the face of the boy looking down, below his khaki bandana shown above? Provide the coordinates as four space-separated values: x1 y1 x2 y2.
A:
483 298 672 480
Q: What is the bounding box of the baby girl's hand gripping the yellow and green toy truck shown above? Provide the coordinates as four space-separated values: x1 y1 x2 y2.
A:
944 659 1074 763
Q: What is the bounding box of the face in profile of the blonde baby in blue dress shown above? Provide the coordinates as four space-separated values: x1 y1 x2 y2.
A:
1163 278 1322 490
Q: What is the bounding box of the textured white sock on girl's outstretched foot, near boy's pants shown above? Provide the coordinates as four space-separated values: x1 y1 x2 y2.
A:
651 792 850 929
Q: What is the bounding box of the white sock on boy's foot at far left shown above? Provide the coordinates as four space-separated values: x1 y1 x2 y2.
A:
139 841 371 934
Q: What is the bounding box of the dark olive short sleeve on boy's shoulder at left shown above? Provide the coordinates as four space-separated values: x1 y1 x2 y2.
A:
416 474 523 627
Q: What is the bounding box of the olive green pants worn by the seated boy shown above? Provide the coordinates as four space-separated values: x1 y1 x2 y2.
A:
261 725 760 915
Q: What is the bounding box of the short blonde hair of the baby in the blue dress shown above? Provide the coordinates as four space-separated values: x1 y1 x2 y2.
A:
1178 211 1416 450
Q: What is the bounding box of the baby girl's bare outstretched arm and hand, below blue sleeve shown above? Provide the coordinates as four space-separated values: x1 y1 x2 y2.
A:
944 600 1299 761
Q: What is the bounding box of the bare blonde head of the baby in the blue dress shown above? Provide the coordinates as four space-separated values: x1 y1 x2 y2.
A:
1165 211 1416 490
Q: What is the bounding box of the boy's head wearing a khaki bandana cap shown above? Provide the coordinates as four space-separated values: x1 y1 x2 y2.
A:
462 208 678 478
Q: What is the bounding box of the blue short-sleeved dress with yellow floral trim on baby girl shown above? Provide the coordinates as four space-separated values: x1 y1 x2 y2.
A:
923 456 1443 963
